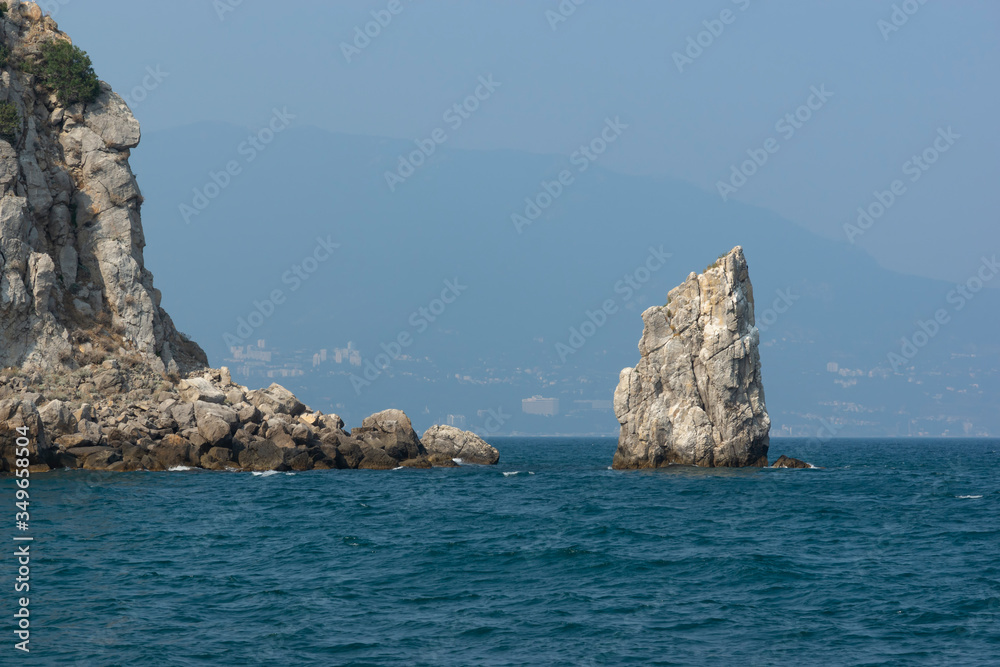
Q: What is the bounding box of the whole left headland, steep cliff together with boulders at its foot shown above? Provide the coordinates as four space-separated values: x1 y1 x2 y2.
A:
0 0 470 471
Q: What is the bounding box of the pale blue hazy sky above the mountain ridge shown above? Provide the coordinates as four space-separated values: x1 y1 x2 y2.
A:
48 0 1000 281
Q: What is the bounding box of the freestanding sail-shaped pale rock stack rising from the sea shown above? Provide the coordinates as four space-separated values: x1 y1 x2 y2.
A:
613 246 771 469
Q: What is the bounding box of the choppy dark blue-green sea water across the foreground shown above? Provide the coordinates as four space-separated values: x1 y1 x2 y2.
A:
7 438 1000 666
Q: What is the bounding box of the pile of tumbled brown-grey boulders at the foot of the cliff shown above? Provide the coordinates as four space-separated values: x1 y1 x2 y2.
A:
0 363 455 472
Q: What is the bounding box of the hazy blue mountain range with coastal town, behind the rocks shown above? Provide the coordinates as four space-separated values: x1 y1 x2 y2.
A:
131 120 1000 437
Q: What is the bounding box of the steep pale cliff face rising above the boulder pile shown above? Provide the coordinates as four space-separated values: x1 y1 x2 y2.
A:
0 0 207 372
